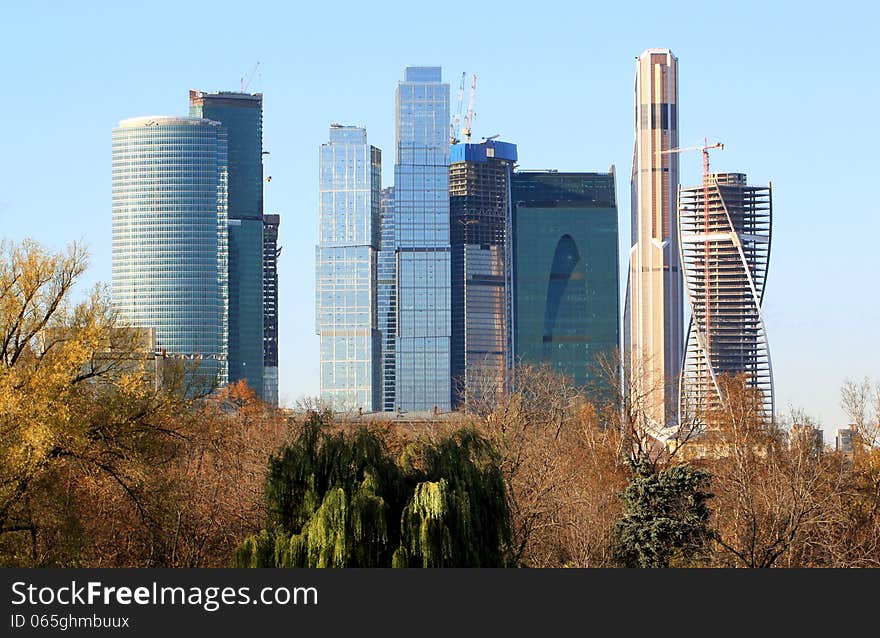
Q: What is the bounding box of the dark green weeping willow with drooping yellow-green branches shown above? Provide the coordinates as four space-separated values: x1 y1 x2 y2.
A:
233 413 510 567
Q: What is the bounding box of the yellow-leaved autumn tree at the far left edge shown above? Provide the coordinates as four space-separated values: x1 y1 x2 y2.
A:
0 240 196 565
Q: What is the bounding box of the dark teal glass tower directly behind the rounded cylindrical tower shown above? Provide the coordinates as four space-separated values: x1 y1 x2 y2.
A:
189 91 265 398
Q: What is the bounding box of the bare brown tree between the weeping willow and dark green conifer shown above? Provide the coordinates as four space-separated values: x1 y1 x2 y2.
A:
471 364 627 567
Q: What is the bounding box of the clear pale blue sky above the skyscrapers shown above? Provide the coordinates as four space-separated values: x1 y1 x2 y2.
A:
0 1 880 438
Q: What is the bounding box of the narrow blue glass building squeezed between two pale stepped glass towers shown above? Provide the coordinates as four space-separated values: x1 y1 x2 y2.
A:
376 186 397 412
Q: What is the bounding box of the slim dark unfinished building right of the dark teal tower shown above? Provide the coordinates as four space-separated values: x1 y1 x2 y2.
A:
263 215 281 407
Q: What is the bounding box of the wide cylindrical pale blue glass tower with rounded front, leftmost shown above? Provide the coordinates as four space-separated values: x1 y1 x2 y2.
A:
112 116 227 384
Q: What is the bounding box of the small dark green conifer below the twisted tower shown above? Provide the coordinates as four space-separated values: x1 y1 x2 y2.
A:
615 460 713 567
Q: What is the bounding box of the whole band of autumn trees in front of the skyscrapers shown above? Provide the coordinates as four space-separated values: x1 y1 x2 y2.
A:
0 241 880 567
